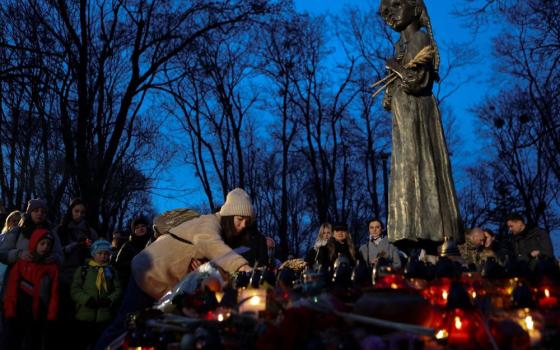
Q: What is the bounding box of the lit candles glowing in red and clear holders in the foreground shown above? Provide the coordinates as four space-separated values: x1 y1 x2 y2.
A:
202 275 559 345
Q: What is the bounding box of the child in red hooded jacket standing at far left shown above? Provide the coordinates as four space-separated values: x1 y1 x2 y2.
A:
4 228 59 349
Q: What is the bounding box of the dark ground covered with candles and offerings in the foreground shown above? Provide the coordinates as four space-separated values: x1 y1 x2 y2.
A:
113 259 560 350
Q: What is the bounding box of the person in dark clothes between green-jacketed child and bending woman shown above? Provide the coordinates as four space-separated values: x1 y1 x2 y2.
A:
115 216 153 288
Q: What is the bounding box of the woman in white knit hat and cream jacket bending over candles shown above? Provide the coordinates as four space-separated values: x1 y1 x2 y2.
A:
95 188 254 349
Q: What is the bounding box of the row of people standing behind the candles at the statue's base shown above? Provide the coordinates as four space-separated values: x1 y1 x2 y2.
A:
306 213 558 278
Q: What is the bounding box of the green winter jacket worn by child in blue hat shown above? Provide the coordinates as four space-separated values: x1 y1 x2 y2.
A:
70 262 122 323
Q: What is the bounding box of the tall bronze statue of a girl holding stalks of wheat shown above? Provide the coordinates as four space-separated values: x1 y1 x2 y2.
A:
374 0 463 252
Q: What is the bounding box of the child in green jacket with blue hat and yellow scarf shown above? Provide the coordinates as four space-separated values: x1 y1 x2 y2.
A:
70 239 121 349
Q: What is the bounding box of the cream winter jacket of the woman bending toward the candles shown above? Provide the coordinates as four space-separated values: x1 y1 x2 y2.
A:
132 214 247 299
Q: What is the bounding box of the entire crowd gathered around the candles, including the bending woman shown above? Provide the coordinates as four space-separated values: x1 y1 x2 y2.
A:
0 188 555 349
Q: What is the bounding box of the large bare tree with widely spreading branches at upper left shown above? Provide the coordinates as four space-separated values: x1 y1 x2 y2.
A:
1 0 267 231
